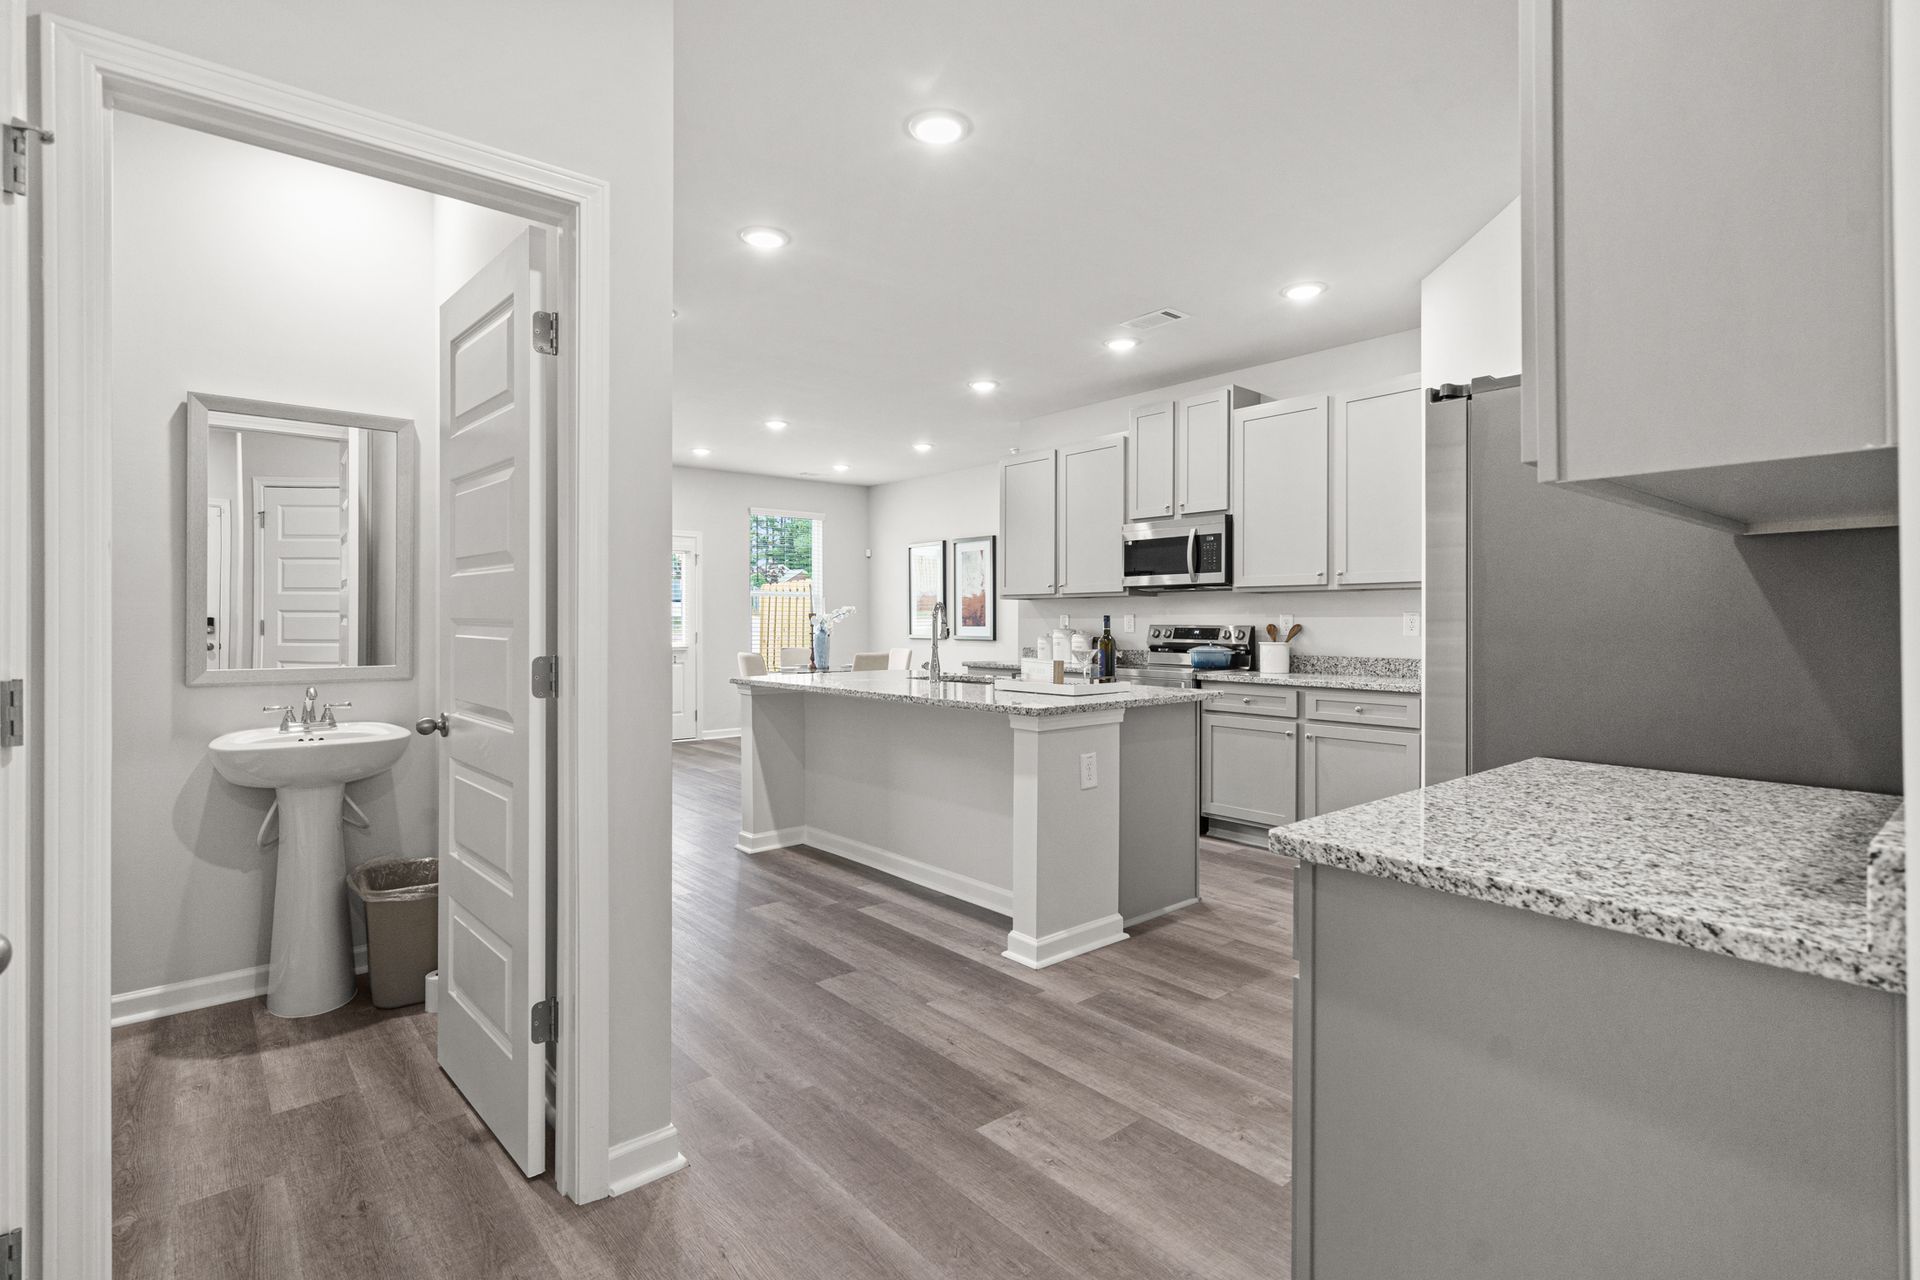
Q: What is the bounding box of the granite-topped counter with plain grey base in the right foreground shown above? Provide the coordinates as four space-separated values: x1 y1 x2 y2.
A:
1271 760 1907 1280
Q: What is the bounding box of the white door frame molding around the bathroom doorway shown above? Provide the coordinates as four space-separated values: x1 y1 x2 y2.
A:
35 15 622 1276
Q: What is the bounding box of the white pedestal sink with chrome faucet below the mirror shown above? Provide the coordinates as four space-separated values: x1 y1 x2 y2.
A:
209 722 411 1017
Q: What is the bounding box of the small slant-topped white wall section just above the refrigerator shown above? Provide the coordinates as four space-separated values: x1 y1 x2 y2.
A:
1421 200 1521 386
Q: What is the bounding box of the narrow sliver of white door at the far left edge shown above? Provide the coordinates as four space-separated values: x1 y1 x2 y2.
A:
0 0 26 1249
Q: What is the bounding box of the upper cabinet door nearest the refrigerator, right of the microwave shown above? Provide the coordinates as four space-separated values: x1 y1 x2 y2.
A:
1336 374 1427 587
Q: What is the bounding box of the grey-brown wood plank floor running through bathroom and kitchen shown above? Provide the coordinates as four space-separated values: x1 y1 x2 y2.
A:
113 741 1294 1280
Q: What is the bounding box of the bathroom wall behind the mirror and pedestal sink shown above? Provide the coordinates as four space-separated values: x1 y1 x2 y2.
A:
113 117 440 992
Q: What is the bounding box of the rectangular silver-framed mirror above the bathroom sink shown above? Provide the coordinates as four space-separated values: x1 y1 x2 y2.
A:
182 391 419 685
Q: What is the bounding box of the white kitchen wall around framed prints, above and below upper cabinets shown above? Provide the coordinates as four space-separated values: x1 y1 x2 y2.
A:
872 330 1421 662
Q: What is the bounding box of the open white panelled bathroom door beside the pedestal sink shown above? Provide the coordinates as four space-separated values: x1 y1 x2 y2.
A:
438 230 553 1176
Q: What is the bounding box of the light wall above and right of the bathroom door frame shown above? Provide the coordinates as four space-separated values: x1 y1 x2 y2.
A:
27 0 674 1182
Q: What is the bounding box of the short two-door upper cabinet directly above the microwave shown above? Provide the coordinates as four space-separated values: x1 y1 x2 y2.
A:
1127 386 1261 520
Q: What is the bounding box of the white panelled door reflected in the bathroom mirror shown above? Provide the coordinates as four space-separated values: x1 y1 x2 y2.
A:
253 476 346 668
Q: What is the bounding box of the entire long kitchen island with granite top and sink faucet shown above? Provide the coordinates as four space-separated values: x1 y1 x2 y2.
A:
733 672 1208 969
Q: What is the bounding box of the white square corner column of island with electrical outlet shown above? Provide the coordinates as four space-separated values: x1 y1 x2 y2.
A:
1002 708 1127 969
